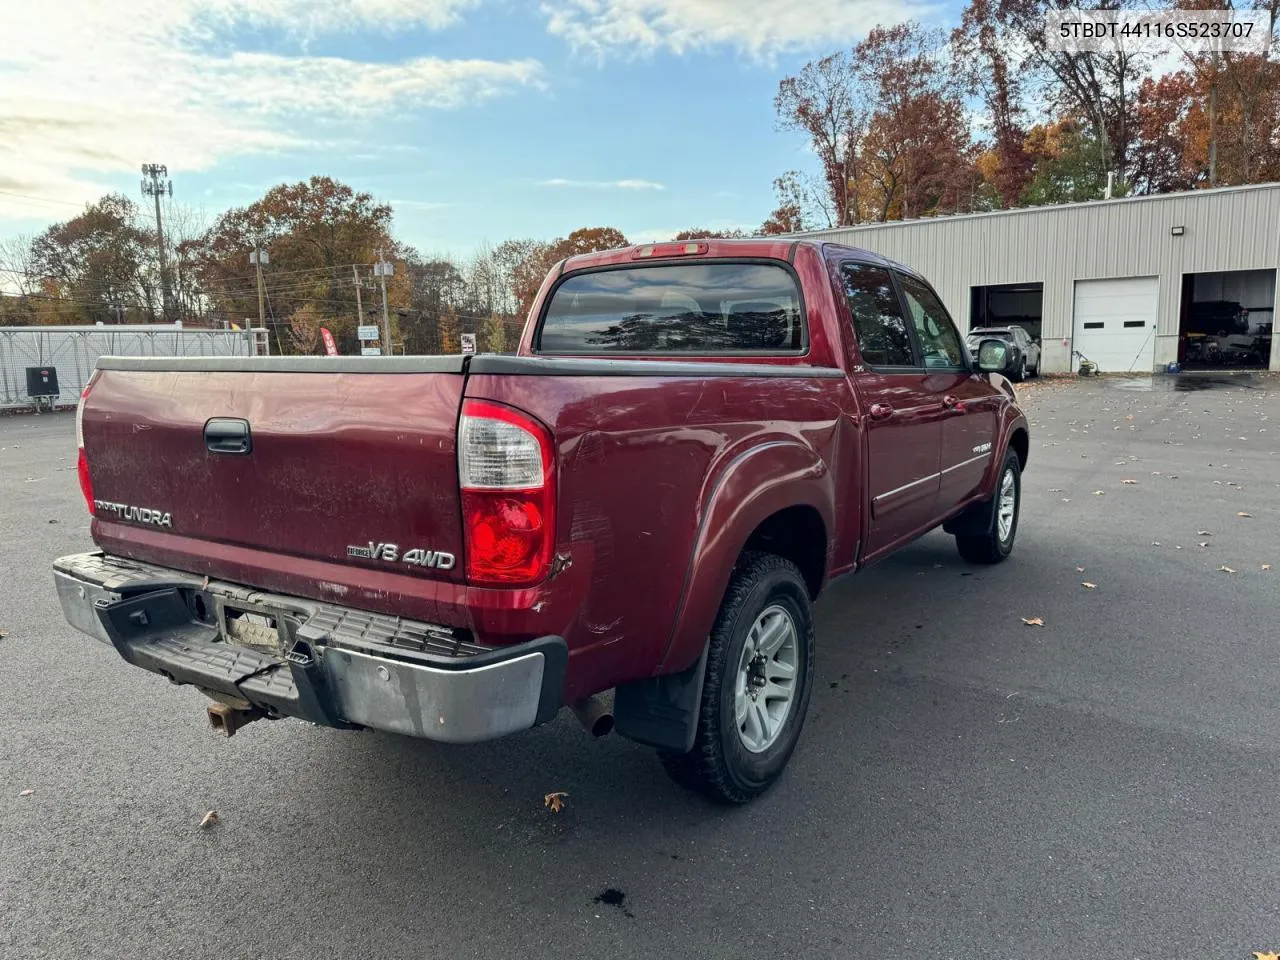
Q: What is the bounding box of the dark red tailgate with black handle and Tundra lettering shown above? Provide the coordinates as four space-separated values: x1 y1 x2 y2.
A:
83 357 465 586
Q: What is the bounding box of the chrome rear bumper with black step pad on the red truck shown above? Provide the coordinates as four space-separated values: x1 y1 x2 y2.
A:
54 553 568 742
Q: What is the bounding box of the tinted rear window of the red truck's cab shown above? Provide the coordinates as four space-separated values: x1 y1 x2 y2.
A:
538 261 804 353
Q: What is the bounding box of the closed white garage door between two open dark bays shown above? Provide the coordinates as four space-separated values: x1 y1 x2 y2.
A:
1074 276 1156 374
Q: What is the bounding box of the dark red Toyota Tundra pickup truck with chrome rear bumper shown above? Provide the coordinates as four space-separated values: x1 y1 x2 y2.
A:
54 239 1028 803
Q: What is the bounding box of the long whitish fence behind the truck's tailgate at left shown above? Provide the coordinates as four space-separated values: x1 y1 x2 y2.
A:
0 324 269 408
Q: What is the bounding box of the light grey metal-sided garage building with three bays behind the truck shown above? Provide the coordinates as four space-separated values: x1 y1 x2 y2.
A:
810 184 1280 372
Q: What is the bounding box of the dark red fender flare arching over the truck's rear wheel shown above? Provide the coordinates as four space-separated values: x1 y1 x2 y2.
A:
654 438 836 675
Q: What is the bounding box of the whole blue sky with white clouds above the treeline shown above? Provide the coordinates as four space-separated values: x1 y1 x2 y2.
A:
0 0 954 255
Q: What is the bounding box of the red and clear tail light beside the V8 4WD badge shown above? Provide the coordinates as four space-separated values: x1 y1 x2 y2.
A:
458 401 556 586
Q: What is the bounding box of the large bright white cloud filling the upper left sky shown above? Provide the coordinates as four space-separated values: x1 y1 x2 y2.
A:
0 0 543 219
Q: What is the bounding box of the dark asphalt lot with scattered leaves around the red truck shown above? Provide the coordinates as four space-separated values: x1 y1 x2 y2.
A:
0 375 1280 960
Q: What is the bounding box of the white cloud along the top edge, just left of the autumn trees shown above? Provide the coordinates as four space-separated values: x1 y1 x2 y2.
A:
541 0 936 58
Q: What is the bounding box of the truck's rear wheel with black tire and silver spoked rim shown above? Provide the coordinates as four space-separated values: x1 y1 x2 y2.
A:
658 550 814 804
